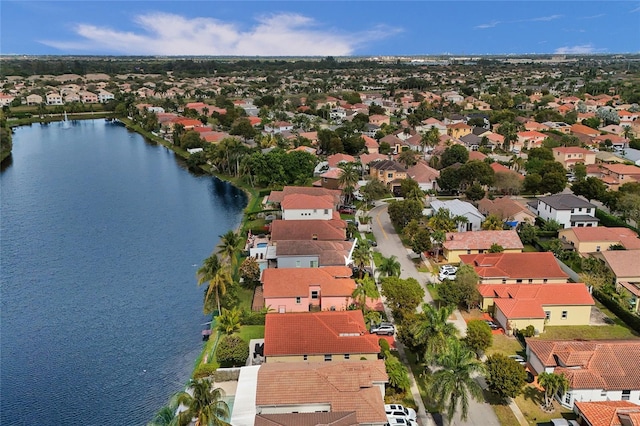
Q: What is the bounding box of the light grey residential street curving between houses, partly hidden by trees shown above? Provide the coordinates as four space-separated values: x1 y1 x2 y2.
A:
369 204 500 426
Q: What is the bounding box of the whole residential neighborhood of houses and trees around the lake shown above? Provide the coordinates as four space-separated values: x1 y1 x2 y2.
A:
0 55 640 426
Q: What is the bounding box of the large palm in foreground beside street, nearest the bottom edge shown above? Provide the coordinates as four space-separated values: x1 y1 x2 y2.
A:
428 339 484 422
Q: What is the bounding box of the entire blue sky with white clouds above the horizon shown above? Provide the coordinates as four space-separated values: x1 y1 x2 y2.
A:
0 0 640 56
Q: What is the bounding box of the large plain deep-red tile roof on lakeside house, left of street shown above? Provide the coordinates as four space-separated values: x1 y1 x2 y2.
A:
264 310 380 362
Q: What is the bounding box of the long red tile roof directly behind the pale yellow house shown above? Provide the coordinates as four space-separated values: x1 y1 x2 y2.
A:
460 252 569 284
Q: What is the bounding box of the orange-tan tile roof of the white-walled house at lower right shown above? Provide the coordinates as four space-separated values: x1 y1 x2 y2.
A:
527 339 640 390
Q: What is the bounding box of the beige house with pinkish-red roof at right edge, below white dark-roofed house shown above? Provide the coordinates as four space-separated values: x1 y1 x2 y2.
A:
558 226 640 256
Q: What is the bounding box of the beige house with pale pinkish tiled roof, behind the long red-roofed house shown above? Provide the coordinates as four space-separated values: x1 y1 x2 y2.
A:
442 231 524 263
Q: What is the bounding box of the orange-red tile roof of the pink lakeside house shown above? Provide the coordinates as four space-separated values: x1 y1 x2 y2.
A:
262 266 356 299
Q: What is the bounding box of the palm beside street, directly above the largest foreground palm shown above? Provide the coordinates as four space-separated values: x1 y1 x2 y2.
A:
412 303 458 362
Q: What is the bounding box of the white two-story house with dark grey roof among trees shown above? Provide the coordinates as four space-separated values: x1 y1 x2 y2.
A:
527 194 599 228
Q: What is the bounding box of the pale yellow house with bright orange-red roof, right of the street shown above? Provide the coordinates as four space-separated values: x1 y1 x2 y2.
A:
478 283 595 334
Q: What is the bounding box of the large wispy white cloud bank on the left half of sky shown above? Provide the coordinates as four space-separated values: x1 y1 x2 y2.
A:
41 13 400 56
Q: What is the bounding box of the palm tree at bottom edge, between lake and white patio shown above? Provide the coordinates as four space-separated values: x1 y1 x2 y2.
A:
177 379 229 426
